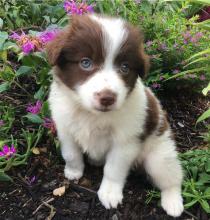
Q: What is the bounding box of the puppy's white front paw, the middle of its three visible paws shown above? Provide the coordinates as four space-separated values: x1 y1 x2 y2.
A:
98 180 123 209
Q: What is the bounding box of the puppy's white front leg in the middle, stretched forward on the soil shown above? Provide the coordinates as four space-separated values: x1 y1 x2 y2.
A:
98 144 138 209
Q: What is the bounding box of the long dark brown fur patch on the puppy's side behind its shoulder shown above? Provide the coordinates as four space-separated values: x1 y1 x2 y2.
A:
140 89 159 141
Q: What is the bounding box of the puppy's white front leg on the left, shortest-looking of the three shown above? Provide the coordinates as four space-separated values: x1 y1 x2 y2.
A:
58 132 84 180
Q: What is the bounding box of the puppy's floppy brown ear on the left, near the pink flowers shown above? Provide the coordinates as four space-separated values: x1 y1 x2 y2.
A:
46 29 68 66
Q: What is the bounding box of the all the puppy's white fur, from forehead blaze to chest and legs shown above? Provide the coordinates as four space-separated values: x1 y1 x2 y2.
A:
49 17 183 217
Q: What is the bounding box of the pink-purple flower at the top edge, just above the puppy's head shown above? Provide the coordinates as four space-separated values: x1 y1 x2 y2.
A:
63 0 94 15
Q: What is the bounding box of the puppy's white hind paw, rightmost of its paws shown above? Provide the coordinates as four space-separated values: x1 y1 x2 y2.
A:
161 188 184 217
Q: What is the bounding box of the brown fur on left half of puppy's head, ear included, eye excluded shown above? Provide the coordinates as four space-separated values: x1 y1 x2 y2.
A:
47 15 105 89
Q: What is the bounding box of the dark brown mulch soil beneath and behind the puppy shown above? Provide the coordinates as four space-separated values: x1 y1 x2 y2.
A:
0 83 210 220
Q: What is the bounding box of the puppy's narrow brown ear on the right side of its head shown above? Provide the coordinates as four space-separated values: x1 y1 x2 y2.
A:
139 42 150 78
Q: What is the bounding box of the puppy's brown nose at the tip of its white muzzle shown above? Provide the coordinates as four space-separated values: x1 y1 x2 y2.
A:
96 90 117 107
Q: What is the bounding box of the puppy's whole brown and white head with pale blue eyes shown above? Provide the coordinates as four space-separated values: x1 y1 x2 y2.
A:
47 15 148 112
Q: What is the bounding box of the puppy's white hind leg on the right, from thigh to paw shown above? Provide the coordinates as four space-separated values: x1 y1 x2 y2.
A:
144 132 184 217
